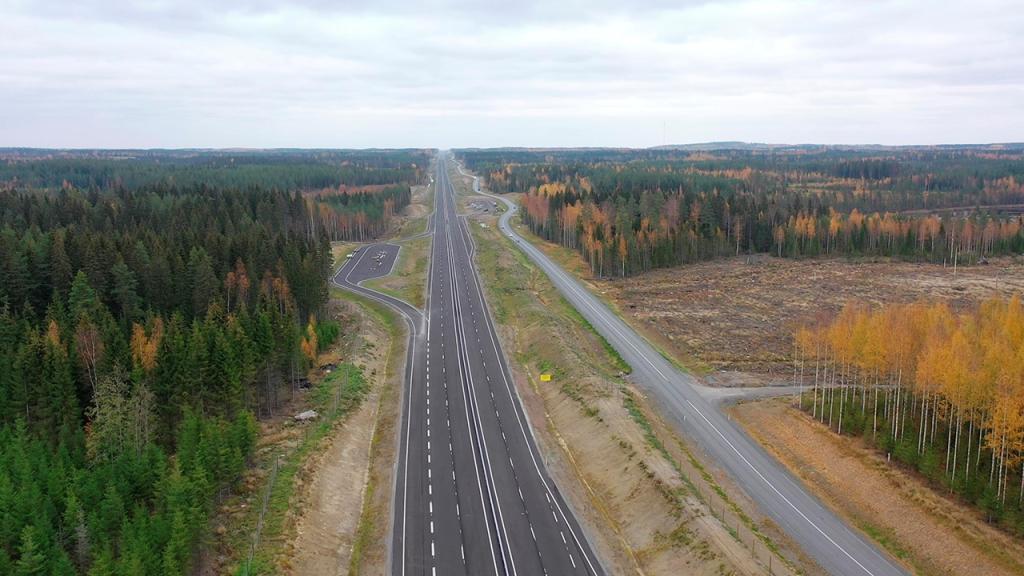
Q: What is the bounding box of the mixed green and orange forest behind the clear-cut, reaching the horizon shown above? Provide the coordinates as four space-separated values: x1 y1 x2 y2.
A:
459 147 1024 276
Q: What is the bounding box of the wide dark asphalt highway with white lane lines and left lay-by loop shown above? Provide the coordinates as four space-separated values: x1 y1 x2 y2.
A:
335 154 604 576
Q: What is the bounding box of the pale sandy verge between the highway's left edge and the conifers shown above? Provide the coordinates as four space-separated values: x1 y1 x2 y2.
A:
291 297 390 575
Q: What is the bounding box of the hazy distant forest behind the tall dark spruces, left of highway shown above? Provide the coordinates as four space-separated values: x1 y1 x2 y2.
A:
0 149 423 241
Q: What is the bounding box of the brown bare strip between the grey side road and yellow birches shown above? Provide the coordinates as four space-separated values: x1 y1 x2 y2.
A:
730 399 1024 576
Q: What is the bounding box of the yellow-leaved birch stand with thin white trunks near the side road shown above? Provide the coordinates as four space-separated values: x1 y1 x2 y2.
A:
795 296 1024 536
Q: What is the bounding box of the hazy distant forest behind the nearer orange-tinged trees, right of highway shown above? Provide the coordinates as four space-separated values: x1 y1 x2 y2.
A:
459 145 1024 212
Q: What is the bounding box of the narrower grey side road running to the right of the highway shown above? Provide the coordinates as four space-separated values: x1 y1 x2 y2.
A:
460 161 906 576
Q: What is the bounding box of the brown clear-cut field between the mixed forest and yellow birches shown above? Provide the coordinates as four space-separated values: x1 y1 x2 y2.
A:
590 256 1024 375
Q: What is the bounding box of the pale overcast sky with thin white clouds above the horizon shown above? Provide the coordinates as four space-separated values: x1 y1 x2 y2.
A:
0 0 1024 148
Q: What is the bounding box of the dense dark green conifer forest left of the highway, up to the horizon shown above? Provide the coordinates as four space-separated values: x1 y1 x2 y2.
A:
0 151 428 576
